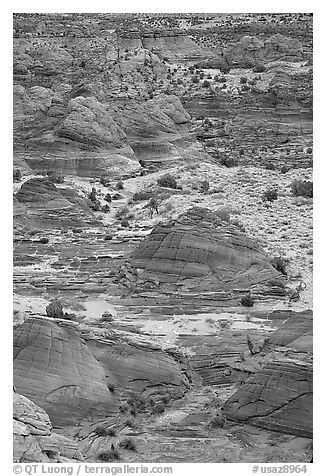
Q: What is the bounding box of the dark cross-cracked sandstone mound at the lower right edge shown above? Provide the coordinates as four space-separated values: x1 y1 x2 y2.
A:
224 361 313 438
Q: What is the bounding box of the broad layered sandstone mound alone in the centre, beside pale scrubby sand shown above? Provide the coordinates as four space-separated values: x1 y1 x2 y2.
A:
131 208 279 291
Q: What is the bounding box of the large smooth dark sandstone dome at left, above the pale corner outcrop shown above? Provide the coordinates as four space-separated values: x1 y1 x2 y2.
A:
14 318 118 426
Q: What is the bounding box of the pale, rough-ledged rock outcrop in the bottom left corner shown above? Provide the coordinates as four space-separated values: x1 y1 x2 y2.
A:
13 393 83 463
